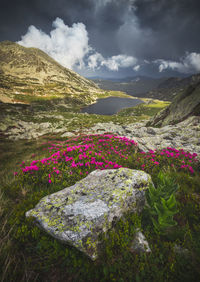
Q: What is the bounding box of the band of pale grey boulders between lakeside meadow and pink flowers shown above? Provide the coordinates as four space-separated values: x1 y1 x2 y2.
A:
1 110 200 153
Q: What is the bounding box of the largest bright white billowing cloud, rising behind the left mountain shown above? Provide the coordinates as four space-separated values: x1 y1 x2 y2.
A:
18 18 91 69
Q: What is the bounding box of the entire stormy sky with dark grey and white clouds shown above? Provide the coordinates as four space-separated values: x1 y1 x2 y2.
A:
0 0 200 77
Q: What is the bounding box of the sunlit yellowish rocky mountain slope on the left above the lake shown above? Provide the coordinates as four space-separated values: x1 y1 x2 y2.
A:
0 41 101 103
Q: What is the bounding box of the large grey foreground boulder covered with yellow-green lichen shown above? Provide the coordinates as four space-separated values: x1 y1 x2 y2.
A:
26 168 152 260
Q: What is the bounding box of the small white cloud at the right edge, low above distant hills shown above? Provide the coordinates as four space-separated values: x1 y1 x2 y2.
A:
154 52 200 73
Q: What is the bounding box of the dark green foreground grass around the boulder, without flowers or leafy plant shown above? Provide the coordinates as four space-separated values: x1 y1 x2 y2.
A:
0 131 200 282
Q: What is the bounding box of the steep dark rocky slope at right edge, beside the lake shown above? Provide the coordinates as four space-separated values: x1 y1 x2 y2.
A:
147 81 200 126
